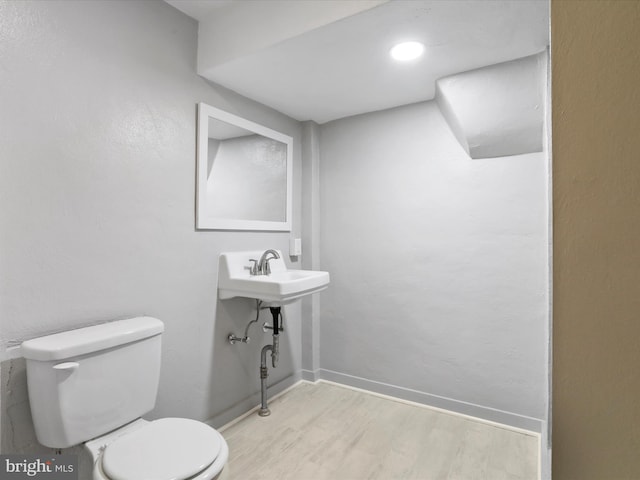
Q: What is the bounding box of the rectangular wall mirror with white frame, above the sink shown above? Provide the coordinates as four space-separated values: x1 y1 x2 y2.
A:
196 103 293 231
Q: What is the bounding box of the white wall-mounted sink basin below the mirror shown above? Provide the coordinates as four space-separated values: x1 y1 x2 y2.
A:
218 250 329 304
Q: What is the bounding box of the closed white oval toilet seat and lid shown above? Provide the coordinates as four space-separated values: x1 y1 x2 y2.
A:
99 418 228 480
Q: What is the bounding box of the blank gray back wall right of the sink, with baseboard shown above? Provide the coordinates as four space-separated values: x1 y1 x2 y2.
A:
320 102 549 430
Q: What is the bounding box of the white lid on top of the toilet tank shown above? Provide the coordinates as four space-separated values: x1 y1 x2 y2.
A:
21 317 164 362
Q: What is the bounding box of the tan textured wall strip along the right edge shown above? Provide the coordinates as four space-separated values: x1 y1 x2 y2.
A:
551 0 640 480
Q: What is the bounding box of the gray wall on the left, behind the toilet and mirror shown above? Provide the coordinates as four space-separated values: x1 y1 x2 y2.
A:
0 0 301 458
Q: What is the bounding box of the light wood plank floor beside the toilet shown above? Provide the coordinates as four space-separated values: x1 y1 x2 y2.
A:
222 382 538 480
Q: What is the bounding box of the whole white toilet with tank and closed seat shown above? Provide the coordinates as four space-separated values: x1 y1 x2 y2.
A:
22 317 229 480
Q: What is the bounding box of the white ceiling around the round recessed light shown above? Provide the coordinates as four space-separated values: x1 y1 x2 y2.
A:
166 0 549 123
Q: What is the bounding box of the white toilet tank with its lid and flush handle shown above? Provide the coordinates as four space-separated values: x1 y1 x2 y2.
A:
22 317 164 448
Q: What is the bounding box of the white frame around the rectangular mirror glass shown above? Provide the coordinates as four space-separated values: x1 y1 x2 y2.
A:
196 103 293 232
